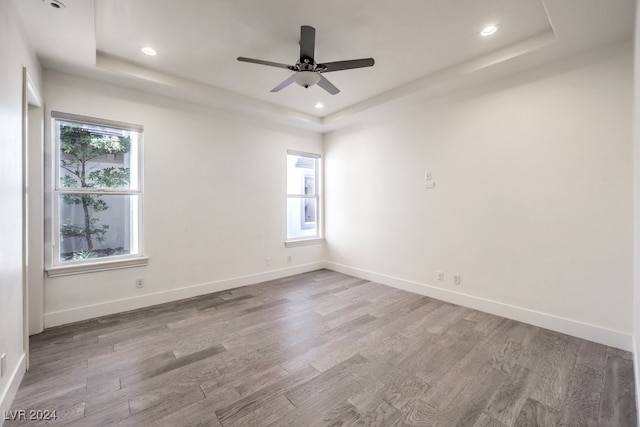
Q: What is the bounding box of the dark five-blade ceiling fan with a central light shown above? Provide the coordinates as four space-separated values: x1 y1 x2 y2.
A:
238 25 374 95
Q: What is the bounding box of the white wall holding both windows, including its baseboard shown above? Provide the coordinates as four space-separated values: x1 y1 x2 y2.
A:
44 71 324 326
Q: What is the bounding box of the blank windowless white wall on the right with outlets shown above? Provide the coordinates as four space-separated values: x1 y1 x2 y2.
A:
325 43 633 349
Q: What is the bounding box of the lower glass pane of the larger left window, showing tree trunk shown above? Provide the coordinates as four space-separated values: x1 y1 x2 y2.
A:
58 193 139 261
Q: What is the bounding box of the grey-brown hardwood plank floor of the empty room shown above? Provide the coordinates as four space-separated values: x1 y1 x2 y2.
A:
5 270 636 427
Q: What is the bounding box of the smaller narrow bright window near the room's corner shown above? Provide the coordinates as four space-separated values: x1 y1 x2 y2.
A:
287 151 321 241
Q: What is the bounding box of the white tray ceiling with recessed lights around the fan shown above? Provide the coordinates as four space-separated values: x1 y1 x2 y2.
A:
14 0 635 131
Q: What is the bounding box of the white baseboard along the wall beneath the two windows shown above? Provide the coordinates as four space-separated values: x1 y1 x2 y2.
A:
44 261 326 328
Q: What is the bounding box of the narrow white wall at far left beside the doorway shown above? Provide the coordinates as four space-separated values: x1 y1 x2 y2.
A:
0 1 40 424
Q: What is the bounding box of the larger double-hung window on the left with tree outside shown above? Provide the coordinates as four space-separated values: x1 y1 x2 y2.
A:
52 112 142 266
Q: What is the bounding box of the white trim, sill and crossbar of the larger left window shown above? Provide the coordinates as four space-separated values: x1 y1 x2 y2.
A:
45 111 149 277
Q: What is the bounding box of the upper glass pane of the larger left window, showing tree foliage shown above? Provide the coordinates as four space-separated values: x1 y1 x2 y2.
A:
56 120 140 189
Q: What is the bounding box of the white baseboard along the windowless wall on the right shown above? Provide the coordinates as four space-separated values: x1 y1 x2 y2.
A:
325 262 635 352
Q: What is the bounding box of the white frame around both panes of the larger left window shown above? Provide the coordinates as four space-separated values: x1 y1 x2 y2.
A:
46 111 148 277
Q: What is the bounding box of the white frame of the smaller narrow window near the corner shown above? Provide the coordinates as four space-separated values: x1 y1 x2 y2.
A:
285 149 324 247
